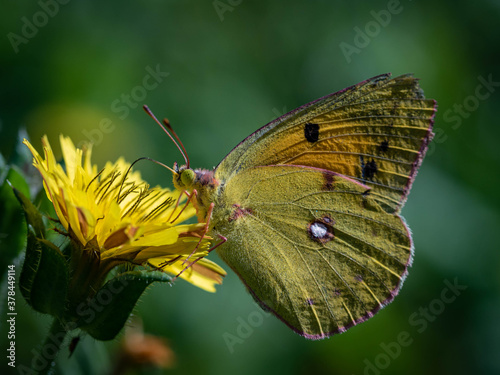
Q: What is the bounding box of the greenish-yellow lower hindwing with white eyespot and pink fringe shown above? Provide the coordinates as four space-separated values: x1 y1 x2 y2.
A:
212 165 412 339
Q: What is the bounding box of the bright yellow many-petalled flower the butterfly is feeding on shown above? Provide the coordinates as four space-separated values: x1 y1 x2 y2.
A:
24 135 226 292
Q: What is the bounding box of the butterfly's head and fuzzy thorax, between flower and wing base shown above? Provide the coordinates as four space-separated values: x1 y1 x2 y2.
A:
174 166 220 222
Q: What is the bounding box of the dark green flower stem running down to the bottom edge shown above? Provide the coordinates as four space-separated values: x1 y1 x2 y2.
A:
31 318 67 375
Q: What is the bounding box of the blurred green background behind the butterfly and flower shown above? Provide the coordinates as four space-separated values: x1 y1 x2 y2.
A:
0 0 500 375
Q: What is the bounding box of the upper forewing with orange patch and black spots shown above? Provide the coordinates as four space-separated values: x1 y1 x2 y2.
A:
216 74 436 213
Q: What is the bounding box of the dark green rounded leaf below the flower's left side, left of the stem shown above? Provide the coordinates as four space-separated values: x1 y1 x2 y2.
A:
19 232 69 317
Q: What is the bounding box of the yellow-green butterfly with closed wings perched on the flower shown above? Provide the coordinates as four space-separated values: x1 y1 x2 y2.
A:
151 74 437 339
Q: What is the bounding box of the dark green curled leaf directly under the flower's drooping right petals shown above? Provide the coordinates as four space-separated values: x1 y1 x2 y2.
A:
77 270 171 340
